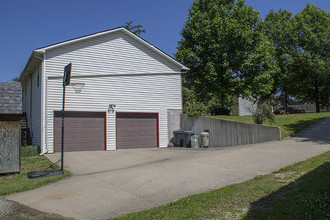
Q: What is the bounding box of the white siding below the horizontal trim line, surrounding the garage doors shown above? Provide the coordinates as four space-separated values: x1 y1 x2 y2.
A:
47 74 181 152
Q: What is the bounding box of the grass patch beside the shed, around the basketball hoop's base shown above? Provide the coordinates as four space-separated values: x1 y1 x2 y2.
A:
0 156 71 196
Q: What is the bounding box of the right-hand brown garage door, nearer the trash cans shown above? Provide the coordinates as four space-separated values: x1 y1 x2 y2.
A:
116 112 158 149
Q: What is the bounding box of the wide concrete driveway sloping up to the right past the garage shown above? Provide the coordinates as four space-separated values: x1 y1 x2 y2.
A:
6 118 330 219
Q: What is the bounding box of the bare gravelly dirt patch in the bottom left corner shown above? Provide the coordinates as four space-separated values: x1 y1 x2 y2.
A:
0 197 73 220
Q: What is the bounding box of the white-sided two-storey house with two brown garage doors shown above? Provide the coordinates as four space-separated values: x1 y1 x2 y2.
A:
20 27 188 153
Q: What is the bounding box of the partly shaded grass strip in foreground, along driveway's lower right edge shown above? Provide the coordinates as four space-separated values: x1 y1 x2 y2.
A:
115 151 330 219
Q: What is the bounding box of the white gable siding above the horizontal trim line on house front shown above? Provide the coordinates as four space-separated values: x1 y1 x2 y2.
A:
46 32 180 77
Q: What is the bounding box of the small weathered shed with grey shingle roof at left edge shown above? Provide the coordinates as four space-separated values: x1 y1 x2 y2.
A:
0 82 22 174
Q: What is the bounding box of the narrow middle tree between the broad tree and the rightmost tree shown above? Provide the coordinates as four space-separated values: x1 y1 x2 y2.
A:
264 9 294 108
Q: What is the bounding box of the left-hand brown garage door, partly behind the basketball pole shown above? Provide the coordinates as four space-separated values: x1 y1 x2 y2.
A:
54 112 106 152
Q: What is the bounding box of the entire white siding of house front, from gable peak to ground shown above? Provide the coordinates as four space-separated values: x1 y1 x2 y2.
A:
45 32 181 153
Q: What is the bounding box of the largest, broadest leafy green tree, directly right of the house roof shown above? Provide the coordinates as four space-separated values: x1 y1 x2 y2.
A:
175 0 277 106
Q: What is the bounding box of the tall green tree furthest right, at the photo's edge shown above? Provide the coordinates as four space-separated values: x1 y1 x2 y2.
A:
291 3 330 112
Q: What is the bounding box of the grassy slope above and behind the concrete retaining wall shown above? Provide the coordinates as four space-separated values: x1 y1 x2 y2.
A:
211 112 330 138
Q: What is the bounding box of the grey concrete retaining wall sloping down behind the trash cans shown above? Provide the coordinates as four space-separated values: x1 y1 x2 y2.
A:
181 115 281 147
